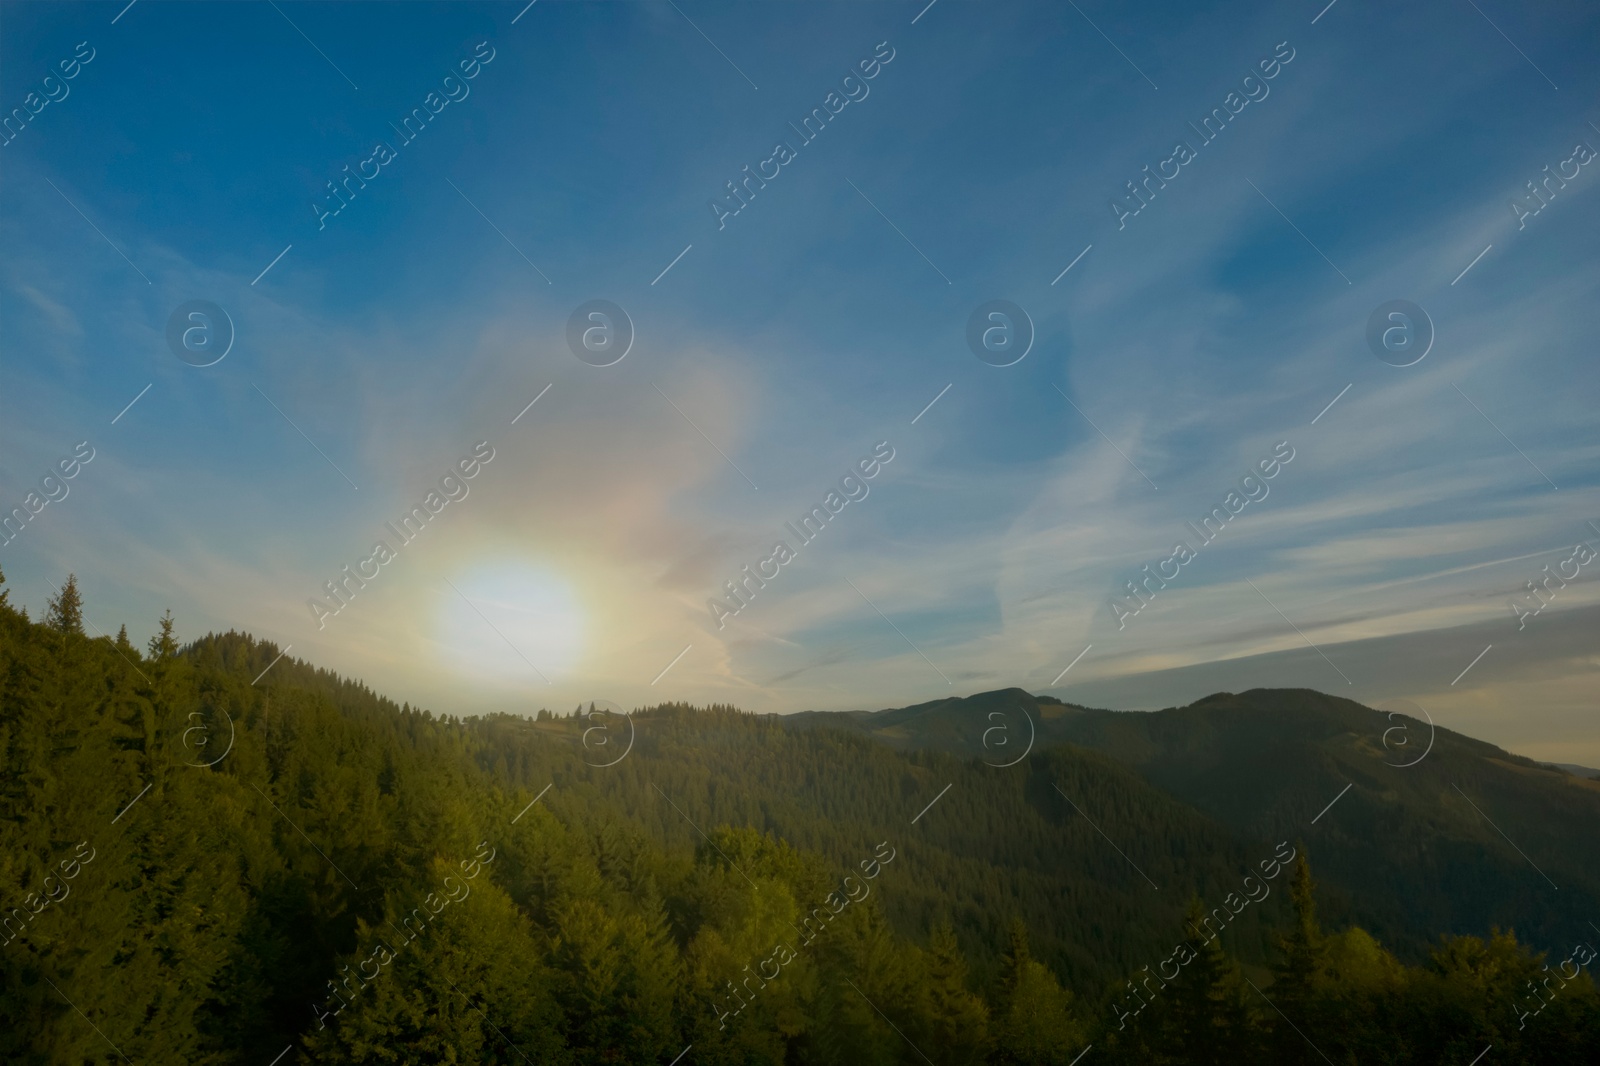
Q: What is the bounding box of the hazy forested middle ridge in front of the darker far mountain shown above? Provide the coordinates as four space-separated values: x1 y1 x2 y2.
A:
499 694 1283 992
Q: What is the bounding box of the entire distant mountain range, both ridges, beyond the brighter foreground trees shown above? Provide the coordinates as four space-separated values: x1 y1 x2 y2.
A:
483 688 1600 988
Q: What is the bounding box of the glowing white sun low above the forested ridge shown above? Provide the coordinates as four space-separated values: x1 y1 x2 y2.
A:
437 562 584 685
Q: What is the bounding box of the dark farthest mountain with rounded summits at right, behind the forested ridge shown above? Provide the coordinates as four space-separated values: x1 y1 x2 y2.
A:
786 688 1600 957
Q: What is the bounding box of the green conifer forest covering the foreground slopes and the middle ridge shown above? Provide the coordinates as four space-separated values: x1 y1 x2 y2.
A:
0 578 1600 1066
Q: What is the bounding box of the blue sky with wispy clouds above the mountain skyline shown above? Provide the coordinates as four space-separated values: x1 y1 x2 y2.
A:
0 0 1600 765
